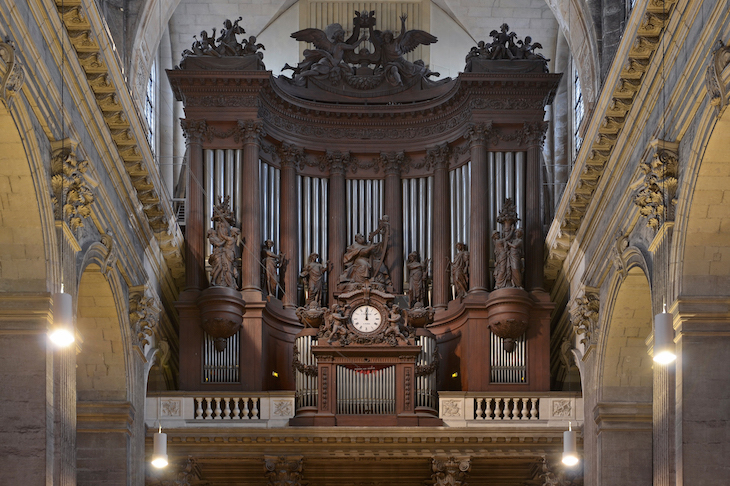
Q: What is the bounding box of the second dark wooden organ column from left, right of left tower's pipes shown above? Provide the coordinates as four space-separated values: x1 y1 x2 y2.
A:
238 120 263 300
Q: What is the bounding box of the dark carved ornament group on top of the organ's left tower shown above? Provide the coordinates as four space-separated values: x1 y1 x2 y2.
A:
180 17 266 71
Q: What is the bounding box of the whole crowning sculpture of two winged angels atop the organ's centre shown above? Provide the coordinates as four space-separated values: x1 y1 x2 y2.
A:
284 11 448 94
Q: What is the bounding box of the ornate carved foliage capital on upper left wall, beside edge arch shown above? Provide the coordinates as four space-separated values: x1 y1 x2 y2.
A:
51 147 94 231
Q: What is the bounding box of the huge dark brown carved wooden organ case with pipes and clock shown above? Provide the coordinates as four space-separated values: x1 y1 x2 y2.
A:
168 18 560 425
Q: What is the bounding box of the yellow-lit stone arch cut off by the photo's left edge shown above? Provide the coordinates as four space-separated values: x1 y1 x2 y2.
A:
0 103 54 292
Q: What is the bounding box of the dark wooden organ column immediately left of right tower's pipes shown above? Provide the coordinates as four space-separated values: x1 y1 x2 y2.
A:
464 123 492 293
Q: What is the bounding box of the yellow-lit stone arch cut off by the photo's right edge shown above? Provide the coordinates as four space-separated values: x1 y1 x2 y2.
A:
675 114 730 296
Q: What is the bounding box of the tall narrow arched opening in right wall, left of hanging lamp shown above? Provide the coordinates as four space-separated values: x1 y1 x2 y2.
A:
587 267 653 486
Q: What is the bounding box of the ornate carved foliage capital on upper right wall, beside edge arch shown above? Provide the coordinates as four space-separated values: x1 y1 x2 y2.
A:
634 140 679 231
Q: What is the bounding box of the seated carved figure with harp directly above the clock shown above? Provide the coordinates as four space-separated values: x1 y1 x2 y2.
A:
337 215 393 292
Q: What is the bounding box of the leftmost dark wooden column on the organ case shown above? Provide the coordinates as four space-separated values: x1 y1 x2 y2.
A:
180 119 211 290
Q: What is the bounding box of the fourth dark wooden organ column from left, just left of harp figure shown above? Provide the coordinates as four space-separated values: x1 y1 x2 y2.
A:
325 151 350 303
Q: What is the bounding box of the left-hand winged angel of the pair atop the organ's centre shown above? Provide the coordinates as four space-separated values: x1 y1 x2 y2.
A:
284 24 367 86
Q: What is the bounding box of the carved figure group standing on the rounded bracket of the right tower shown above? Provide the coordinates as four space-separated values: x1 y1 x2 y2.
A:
492 198 524 289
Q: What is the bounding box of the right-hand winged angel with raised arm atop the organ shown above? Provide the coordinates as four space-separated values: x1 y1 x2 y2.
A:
370 14 439 86
